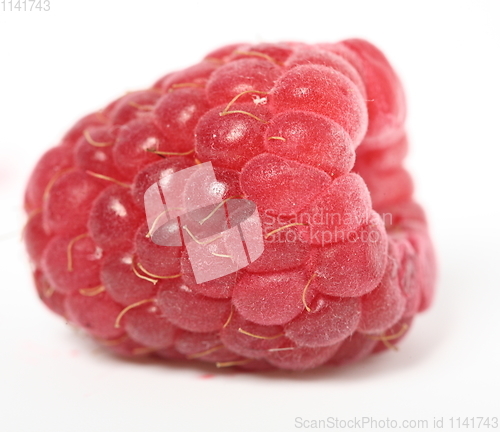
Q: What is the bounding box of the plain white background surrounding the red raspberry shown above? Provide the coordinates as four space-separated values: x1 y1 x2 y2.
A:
0 0 500 432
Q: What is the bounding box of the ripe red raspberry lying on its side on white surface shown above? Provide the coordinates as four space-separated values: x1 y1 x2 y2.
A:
24 39 436 371
